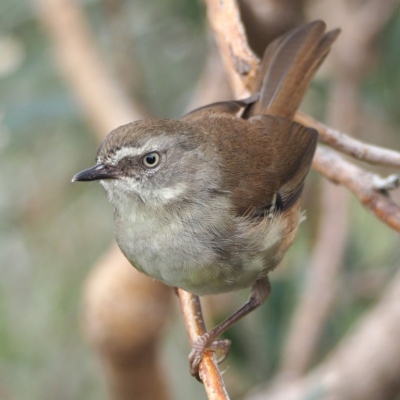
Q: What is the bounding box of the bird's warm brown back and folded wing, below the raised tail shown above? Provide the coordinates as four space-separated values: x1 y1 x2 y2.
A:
189 116 318 215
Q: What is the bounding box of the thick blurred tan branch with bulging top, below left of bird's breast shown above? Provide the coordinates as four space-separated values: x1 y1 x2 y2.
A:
84 246 171 400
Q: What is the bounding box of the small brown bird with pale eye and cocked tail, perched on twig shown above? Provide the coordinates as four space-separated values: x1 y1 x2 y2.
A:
73 21 339 375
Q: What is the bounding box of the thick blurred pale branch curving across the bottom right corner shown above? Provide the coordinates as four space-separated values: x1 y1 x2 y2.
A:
247 266 400 400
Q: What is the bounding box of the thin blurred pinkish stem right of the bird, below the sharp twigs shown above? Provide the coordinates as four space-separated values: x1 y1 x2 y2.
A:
277 181 349 381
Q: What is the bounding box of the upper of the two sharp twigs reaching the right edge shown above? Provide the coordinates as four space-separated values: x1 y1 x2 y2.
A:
295 112 400 168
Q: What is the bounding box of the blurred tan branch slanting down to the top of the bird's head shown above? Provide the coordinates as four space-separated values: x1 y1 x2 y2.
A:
36 0 144 139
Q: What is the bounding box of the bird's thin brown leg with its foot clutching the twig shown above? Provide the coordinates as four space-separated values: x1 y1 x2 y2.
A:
189 278 271 377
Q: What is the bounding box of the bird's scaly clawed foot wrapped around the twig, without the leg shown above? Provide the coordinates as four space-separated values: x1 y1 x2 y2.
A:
189 332 231 382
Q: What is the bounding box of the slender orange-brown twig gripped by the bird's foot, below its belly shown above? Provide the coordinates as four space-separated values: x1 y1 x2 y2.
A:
178 289 229 400
